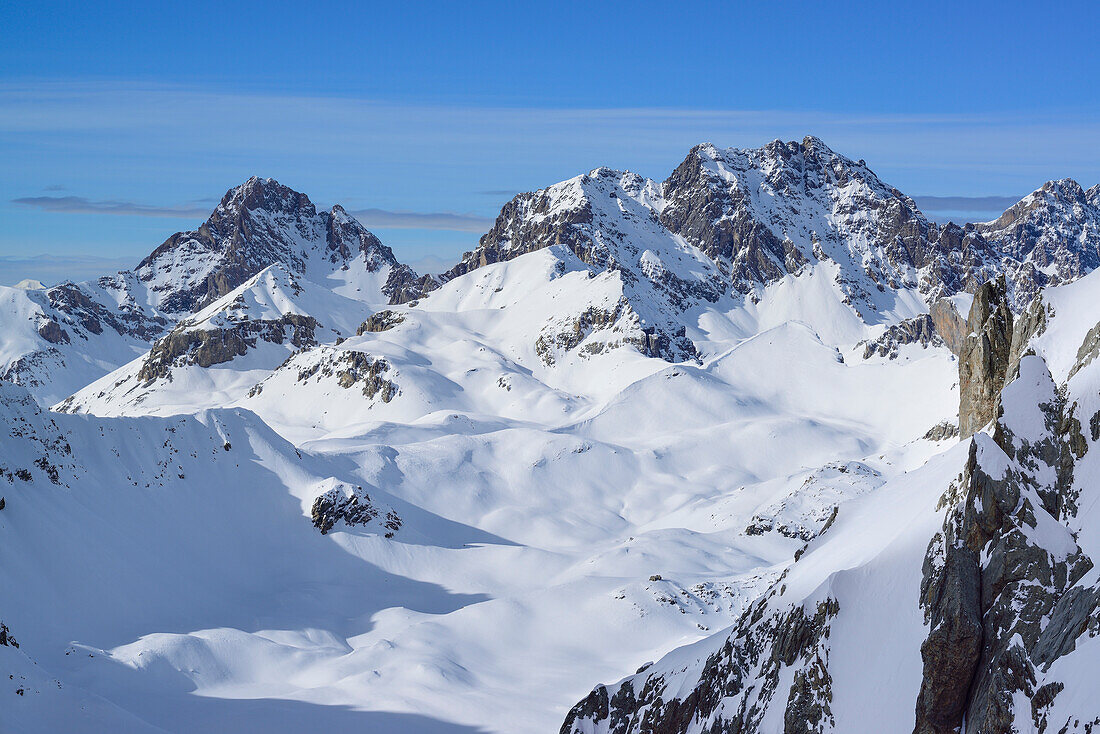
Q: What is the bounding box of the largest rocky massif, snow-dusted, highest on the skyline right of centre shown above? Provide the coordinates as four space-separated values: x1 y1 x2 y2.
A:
441 136 999 322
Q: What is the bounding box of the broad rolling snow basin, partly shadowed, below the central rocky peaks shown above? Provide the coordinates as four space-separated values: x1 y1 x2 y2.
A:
0 269 954 731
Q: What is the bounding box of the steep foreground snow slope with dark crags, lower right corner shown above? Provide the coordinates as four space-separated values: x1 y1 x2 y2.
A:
562 269 1100 734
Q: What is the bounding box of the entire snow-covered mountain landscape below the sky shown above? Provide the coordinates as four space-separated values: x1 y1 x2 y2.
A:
0 138 1100 734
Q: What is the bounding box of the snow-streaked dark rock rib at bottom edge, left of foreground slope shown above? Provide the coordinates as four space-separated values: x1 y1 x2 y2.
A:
561 598 839 734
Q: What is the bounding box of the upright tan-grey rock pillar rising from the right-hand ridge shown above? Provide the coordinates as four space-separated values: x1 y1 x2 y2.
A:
959 276 1013 438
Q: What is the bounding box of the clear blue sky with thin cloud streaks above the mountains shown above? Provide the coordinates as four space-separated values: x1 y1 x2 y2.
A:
0 0 1100 283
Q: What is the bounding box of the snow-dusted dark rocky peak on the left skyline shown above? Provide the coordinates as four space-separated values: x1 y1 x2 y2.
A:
135 177 426 314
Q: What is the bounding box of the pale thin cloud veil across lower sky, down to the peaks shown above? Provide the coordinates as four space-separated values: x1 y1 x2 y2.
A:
0 80 1100 259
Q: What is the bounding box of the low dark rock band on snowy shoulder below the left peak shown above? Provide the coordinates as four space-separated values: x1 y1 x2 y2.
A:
138 314 318 385
